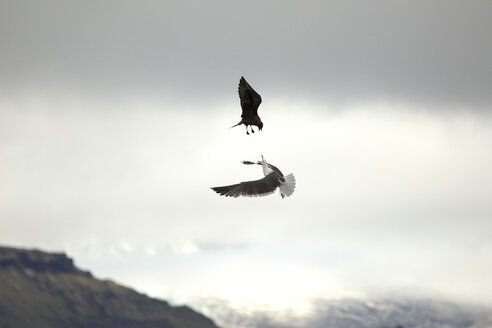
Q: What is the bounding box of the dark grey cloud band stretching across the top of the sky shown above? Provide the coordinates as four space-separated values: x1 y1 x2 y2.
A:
0 0 492 108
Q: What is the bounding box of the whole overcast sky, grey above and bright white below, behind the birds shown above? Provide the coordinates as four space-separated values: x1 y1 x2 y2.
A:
0 0 492 322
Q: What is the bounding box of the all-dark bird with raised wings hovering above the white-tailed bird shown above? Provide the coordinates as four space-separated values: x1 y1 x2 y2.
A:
231 76 263 134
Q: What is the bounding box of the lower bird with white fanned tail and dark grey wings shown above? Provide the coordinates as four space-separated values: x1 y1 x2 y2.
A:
211 155 296 198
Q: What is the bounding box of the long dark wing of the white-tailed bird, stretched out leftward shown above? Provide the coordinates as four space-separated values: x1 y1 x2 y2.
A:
211 172 280 197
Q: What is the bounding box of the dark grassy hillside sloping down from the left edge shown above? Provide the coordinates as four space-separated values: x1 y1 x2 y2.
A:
0 247 216 328
